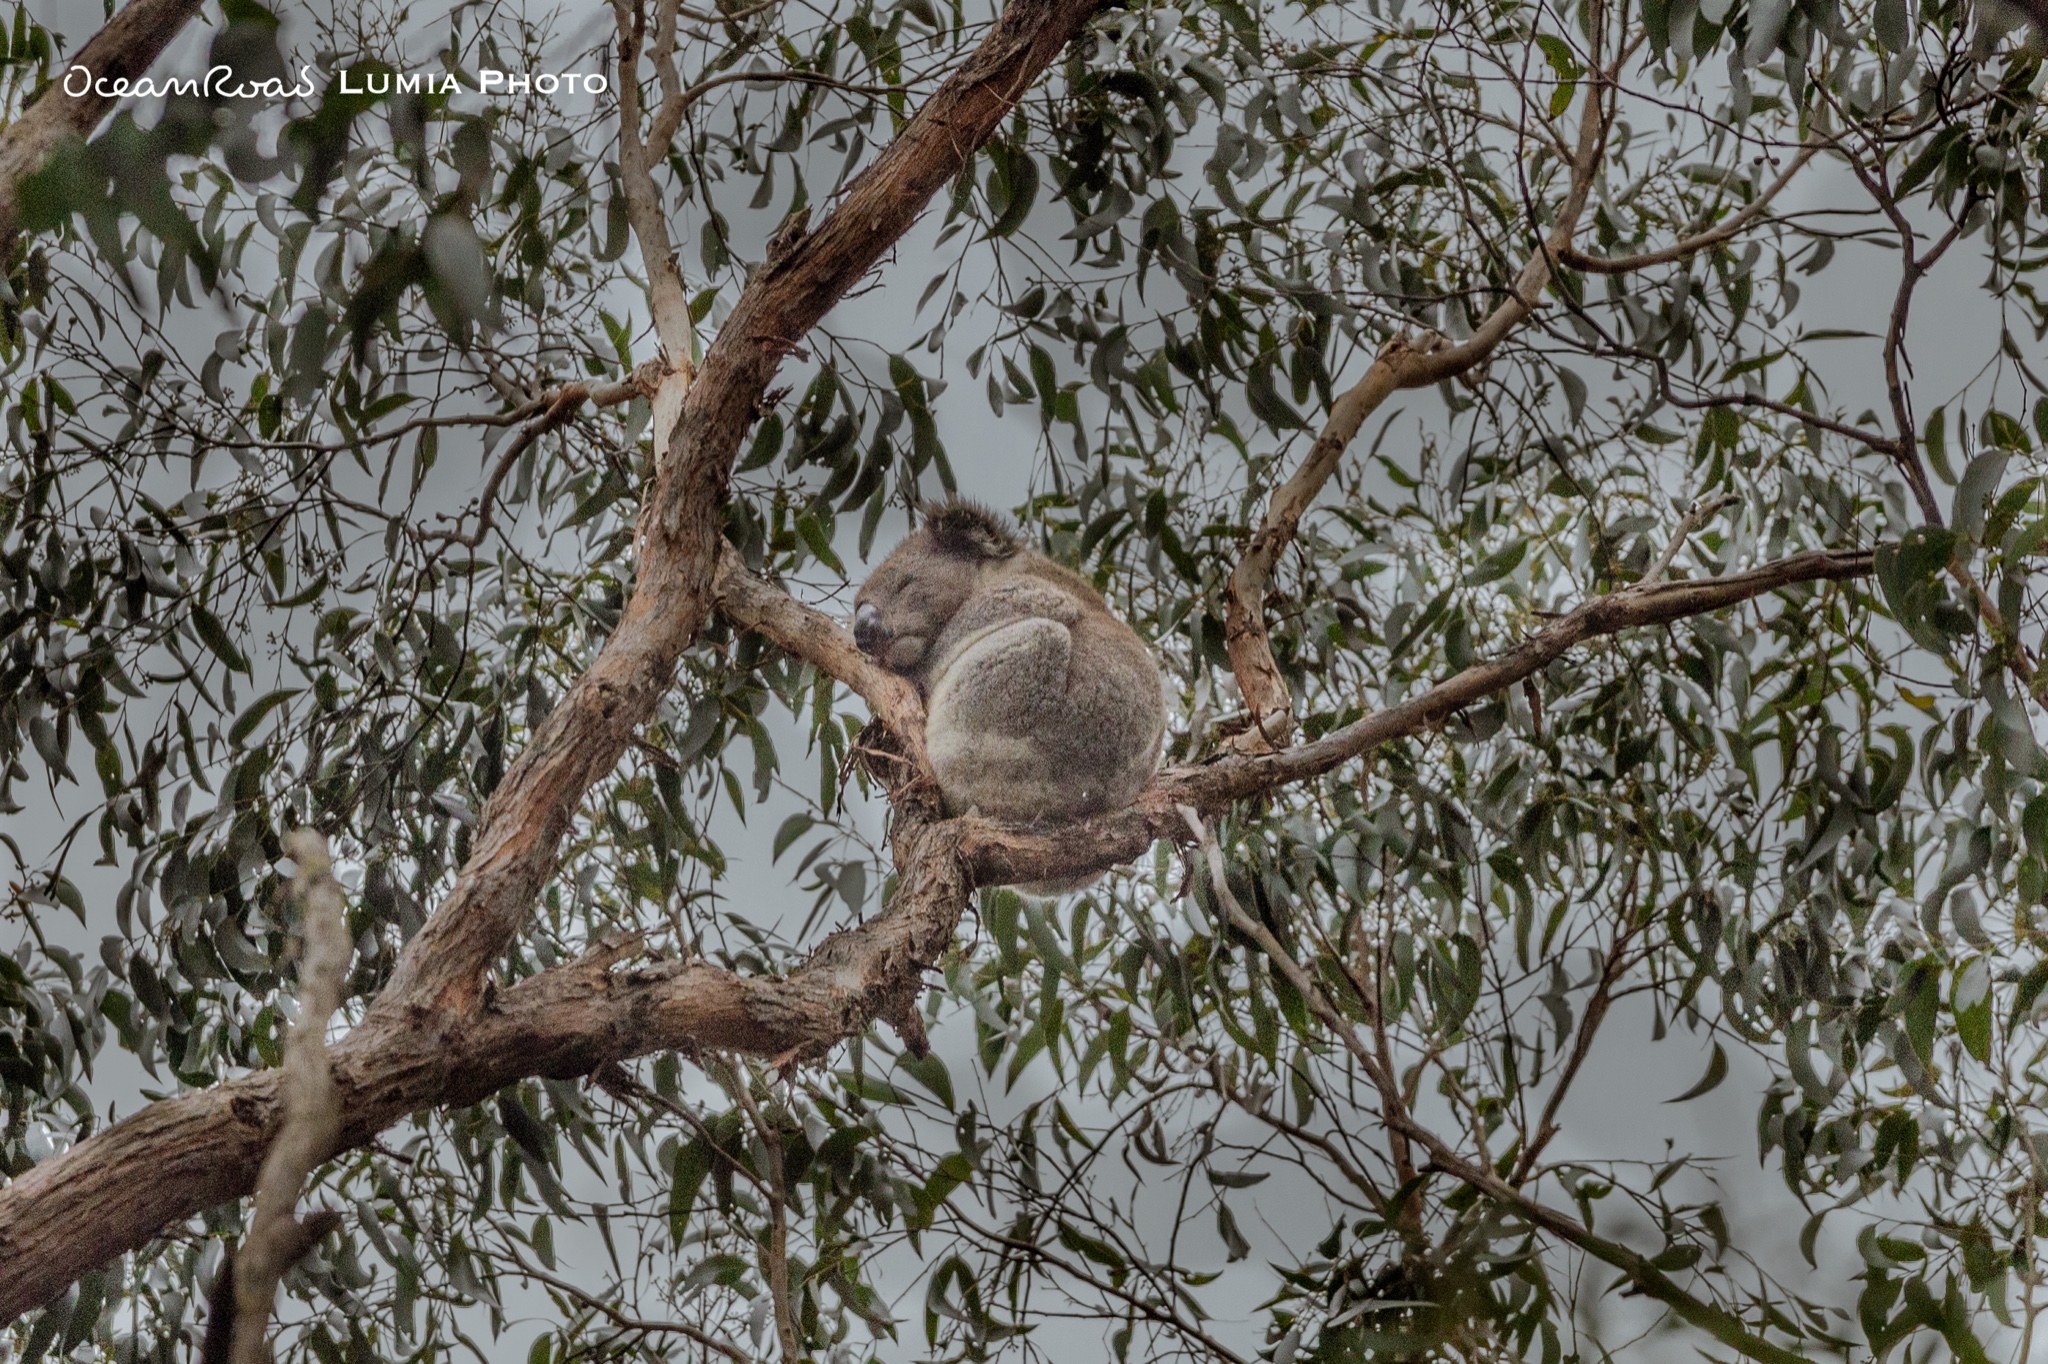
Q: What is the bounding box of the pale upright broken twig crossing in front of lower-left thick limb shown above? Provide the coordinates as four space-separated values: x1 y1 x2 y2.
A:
231 829 350 1364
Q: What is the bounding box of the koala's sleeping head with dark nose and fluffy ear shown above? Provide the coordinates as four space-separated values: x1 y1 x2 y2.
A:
854 502 1018 676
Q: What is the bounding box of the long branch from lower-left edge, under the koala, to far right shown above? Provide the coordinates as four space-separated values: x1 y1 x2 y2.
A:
0 551 1872 1321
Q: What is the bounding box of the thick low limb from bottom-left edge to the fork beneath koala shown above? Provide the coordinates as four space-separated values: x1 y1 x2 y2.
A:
0 815 971 1323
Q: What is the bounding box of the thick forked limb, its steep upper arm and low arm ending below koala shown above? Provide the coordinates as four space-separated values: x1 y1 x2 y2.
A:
0 0 1096 1321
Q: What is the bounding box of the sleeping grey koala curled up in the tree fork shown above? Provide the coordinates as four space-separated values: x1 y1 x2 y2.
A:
854 502 1165 885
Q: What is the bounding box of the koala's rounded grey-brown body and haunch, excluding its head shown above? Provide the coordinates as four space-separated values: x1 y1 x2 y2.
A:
926 551 1165 821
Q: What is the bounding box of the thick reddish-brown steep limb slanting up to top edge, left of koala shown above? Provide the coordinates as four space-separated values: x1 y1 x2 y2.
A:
367 0 1096 1026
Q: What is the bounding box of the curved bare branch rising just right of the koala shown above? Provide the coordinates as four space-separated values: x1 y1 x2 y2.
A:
1223 61 1612 752
